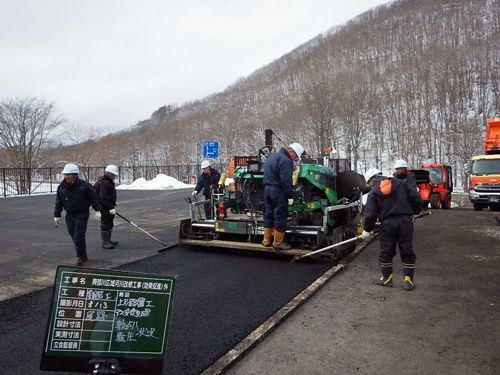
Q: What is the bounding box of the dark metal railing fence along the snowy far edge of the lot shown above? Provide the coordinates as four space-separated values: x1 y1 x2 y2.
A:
0 164 227 197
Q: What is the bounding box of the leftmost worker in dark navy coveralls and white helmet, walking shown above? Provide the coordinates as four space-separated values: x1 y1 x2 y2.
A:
54 164 101 266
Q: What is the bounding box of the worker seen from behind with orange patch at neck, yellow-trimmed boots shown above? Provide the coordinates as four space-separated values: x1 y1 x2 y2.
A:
361 176 422 290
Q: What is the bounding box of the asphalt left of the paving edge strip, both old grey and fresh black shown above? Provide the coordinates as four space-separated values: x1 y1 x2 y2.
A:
0 191 332 375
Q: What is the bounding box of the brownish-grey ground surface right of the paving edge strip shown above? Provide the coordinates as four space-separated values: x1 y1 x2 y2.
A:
227 204 500 375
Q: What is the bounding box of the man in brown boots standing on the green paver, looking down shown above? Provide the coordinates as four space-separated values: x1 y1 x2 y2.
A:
262 143 304 250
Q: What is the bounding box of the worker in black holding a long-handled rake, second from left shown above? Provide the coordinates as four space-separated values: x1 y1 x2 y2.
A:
94 165 118 249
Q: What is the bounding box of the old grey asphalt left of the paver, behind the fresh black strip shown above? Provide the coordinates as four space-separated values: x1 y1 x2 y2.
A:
0 190 190 300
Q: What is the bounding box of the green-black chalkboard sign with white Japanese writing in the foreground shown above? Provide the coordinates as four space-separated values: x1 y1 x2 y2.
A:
40 266 175 374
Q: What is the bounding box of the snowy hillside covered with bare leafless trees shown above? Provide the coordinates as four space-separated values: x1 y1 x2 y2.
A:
40 0 500 185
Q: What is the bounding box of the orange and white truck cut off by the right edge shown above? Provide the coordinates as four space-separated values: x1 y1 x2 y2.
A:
469 118 500 211
